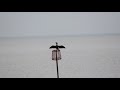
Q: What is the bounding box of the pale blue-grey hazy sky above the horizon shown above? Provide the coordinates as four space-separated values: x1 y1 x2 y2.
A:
0 12 120 37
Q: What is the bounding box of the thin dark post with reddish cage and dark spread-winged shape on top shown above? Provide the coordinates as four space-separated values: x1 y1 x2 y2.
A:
50 42 65 78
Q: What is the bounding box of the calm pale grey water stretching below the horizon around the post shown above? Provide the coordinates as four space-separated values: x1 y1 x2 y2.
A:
0 35 120 78
